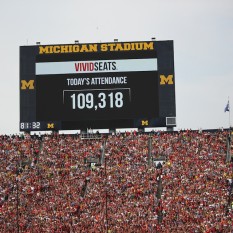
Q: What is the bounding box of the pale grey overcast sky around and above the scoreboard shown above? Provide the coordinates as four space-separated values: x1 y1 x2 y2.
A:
0 0 233 134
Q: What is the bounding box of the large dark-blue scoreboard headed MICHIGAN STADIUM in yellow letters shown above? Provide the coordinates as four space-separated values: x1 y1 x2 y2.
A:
19 41 176 131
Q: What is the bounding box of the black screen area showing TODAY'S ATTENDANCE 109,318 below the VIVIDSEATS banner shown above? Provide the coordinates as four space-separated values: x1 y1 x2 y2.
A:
36 72 158 121
